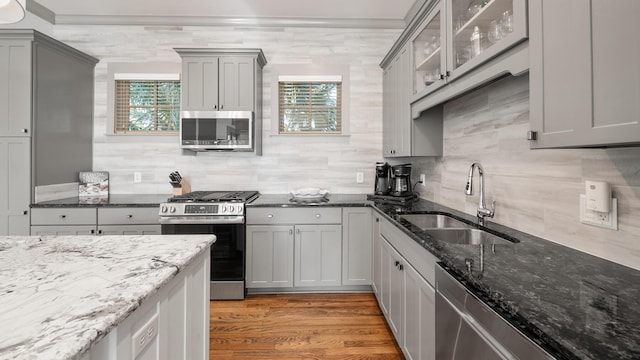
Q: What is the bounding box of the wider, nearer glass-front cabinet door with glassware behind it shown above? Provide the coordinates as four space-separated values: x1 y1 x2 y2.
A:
447 0 527 78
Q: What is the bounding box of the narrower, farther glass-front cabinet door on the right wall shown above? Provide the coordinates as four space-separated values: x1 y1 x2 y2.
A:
413 3 447 95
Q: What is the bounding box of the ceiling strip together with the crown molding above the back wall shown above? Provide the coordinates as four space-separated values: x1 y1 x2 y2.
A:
27 0 416 27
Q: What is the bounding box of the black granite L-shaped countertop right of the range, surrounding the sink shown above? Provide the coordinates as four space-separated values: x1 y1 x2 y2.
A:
249 195 640 360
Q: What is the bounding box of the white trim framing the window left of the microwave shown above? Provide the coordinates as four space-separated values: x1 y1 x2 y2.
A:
105 62 182 139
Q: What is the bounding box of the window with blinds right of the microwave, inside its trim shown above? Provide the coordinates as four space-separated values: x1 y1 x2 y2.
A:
278 77 342 134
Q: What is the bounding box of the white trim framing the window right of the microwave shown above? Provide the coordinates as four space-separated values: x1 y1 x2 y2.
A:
270 64 351 138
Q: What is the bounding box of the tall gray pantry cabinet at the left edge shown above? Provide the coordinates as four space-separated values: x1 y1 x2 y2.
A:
0 29 98 235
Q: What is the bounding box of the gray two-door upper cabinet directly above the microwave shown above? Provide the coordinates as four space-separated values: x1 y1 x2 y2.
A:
175 49 266 111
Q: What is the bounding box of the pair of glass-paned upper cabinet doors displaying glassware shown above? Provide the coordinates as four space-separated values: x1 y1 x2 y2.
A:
412 0 527 100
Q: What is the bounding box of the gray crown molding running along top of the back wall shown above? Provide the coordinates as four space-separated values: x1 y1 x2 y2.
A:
52 15 406 29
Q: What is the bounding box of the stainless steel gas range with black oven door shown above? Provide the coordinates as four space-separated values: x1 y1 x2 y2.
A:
160 191 260 300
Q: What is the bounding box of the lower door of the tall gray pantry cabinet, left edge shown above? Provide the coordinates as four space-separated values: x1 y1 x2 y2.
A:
0 137 31 236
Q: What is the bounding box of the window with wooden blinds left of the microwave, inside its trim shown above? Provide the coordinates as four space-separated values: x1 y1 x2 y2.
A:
114 80 180 134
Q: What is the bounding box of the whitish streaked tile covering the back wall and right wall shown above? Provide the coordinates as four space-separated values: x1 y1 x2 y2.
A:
54 25 640 269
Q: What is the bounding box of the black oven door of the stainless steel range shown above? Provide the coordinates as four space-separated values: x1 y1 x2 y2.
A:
162 224 245 281
